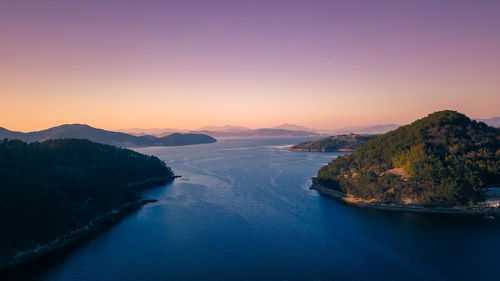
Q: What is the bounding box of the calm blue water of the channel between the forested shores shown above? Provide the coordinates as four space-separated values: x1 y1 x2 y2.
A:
32 138 500 280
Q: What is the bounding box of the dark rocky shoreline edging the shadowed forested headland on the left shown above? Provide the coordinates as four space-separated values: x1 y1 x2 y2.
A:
0 176 180 276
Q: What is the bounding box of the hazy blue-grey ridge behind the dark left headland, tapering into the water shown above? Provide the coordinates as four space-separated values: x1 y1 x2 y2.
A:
0 124 217 147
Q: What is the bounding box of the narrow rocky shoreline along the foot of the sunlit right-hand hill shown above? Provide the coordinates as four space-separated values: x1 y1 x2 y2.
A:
309 178 500 218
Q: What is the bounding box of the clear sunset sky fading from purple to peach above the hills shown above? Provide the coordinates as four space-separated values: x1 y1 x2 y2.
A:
0 0 500 131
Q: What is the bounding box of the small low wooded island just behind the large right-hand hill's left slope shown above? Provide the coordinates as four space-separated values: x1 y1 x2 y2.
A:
289 134 378 152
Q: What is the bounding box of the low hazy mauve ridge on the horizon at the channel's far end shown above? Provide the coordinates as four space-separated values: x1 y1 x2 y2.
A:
190 128 318 137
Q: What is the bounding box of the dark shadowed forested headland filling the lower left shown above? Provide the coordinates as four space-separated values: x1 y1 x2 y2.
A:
0 139 174 270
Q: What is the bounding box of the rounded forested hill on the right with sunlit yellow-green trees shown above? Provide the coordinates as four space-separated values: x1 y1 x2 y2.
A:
318 111 500 206
